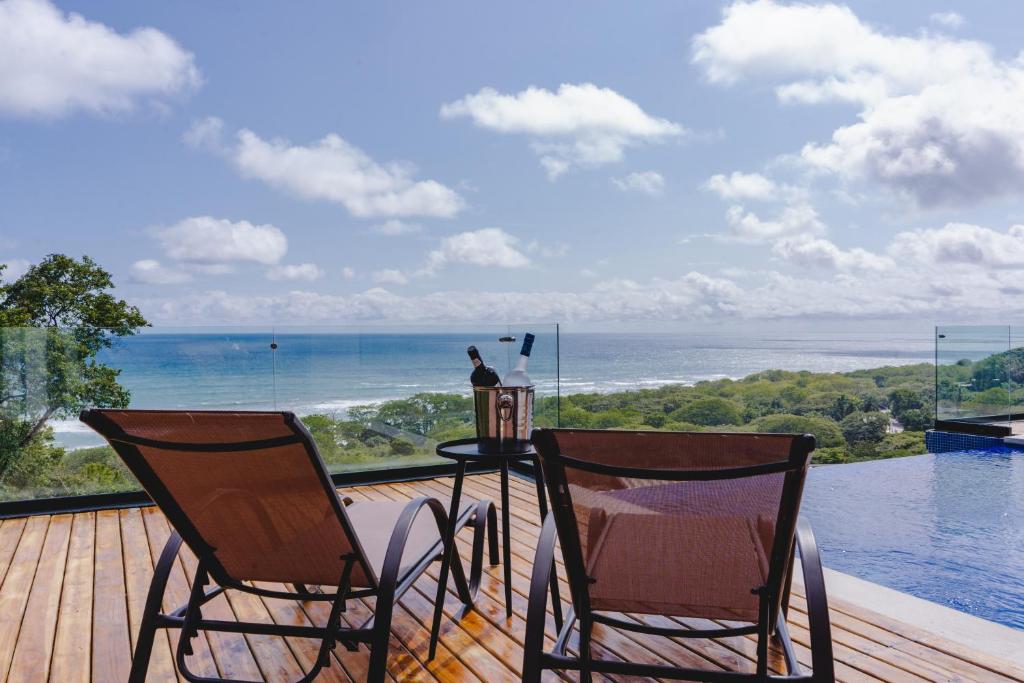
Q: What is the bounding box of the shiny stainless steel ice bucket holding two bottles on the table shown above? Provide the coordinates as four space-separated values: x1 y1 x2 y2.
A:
473 385 534 453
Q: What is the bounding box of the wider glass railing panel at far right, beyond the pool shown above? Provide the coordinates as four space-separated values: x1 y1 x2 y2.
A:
935 326 1017 423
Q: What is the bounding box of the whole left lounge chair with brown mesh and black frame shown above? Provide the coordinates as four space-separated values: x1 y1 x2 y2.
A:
81 410 496 682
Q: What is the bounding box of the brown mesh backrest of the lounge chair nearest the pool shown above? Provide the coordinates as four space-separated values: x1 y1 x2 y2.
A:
534 429 814 624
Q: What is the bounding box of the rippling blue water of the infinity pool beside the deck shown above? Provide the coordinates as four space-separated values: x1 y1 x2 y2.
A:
802 449 1024 629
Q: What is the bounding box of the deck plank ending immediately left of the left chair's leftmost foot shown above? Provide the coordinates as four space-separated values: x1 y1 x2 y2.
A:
92 510 133 681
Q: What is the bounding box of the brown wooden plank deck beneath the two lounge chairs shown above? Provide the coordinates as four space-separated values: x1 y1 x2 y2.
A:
0 475 1024 683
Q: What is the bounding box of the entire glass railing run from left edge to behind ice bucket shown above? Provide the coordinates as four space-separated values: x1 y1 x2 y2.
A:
0 325 558 501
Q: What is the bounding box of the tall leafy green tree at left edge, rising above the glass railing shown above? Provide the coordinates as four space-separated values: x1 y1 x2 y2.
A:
0 259 148 476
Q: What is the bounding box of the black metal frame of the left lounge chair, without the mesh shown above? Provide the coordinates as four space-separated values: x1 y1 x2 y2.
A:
80 411 499 683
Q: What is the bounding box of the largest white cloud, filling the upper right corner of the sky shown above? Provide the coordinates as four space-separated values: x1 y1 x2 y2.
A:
693 0 1024 207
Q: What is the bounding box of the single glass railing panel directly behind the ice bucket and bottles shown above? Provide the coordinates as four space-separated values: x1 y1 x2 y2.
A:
273 325 558 472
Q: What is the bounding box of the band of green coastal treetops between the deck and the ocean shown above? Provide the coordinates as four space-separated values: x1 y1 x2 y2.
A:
0 364 935 499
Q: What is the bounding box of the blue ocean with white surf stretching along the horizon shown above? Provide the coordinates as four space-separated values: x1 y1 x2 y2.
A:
54 326 934 447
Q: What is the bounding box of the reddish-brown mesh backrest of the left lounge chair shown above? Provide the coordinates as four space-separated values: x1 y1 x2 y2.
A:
81 410 377 587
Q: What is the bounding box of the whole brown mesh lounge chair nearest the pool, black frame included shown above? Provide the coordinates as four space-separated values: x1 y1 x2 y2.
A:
523 429 833 681
